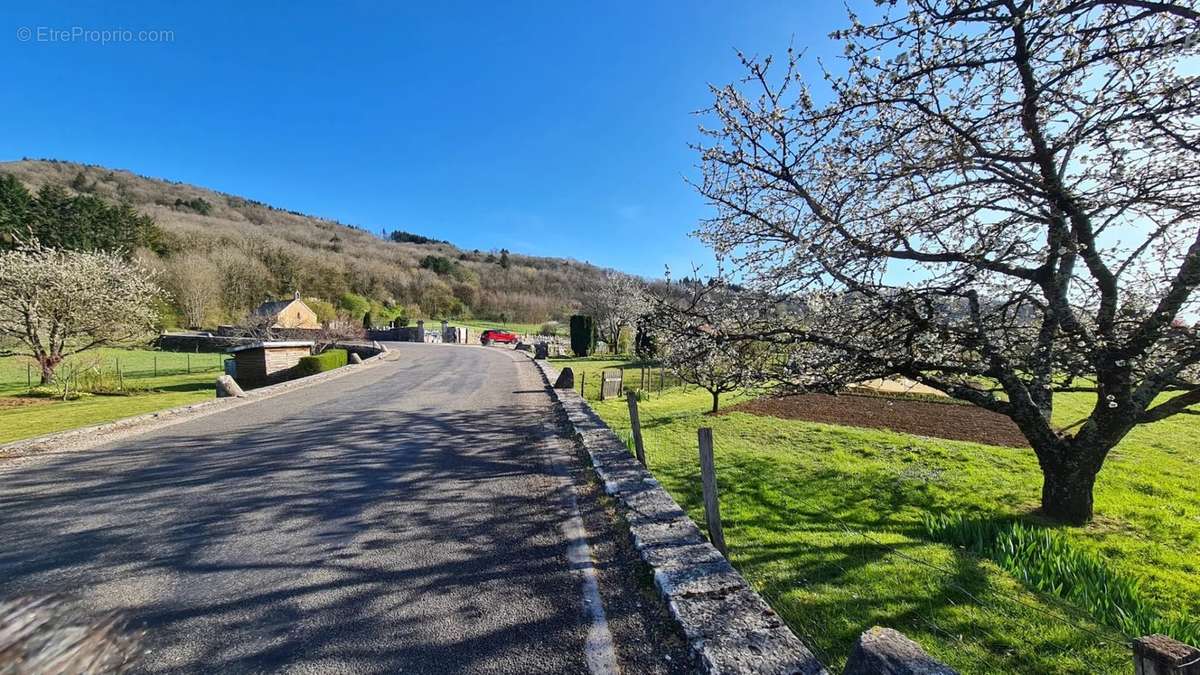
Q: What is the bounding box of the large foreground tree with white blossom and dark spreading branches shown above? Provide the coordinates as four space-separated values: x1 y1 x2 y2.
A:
694 0 1200 524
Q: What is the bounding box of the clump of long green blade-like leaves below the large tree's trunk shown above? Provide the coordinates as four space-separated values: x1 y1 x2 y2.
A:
925 514 1200 645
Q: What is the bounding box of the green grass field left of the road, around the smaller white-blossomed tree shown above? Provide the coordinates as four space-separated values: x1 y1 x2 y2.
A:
0 348 226 443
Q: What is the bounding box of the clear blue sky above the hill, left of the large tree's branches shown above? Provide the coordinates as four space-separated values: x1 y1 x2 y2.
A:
0 0 842 276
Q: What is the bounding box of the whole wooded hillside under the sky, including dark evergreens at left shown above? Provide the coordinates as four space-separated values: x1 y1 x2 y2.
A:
0 160 604 325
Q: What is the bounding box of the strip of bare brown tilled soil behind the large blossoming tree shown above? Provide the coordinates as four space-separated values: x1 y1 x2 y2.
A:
724 394 1030 448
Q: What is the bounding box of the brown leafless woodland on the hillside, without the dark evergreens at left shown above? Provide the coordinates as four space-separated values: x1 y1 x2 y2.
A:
0 160 619 322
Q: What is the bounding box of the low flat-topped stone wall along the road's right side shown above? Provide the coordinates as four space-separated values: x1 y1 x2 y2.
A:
534 360 828 675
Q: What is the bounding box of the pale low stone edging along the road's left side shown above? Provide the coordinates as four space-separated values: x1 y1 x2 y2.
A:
0 352 388 459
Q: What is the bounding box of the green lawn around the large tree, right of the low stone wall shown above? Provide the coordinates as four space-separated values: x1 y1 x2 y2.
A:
556 359 1200 673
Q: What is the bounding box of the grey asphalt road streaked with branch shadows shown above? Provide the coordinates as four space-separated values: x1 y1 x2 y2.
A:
0 345 614 673
